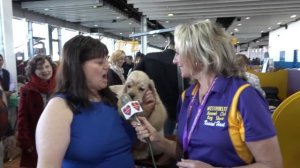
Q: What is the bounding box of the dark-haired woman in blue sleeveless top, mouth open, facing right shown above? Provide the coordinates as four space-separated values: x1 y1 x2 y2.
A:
36 35 154 168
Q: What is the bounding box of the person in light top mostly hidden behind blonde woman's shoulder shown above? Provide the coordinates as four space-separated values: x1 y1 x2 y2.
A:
236 54 266 97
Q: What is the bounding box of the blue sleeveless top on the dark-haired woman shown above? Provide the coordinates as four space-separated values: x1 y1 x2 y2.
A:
54 95 135 168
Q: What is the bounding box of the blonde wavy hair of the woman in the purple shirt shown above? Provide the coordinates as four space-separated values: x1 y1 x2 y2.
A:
175 21 240 76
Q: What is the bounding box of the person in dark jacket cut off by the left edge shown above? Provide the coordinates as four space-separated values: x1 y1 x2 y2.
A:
0 54 16 97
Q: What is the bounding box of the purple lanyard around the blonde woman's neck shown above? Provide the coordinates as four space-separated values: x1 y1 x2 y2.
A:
182 78 216 152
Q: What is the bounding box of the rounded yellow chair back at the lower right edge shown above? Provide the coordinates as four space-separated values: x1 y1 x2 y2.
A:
272 92 300 168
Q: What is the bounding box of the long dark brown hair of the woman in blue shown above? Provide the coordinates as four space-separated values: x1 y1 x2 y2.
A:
57 35 117 113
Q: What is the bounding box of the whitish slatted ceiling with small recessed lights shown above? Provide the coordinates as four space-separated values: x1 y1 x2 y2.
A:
17 0 300 47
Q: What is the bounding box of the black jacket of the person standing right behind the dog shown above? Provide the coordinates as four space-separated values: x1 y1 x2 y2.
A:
134 49 180 121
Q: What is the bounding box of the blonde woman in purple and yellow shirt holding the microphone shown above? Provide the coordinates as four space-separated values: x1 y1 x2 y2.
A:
132 21 283 168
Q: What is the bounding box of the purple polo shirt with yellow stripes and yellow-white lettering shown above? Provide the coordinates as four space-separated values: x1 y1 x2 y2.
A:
177 76 276 167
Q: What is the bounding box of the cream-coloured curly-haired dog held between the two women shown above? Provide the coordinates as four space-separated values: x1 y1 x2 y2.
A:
110 71 167 160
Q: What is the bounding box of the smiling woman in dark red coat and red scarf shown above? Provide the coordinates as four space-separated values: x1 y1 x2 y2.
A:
17 55 56 168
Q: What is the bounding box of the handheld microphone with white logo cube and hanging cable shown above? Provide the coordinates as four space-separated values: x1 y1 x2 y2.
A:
120 94 157 168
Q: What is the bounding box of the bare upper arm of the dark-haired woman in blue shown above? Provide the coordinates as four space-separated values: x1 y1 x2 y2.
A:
36 97 73 168
